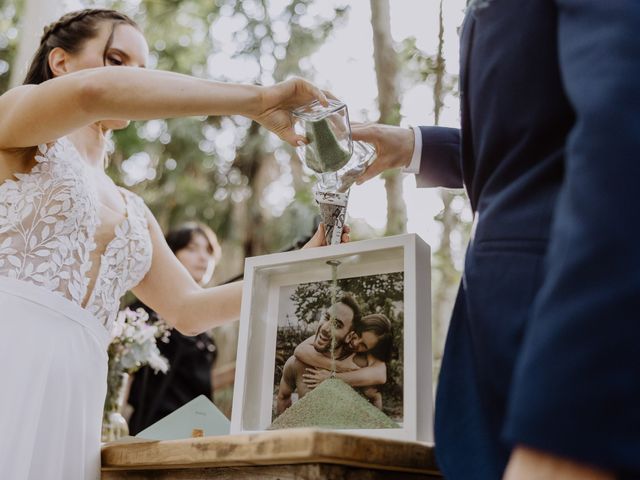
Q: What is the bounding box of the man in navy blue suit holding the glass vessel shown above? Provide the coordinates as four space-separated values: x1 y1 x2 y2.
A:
353 0 640 480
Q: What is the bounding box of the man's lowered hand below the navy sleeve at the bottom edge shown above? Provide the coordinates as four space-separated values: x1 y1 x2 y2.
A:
503 446 615 480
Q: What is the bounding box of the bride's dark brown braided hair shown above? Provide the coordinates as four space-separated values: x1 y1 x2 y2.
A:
23 8 139 85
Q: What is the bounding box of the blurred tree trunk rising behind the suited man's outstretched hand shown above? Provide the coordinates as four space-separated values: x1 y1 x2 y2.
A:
371 0 407 235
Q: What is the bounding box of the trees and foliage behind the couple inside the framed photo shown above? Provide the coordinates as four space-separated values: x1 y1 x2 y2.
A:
273 272 404 423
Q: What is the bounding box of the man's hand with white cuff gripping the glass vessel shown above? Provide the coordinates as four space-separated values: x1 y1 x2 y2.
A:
351 123 414 185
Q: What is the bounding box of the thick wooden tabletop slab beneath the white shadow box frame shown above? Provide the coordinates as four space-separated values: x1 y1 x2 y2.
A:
102 428 439 478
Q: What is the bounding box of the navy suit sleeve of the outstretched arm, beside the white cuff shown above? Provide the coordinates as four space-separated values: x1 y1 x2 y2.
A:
416 127 463 188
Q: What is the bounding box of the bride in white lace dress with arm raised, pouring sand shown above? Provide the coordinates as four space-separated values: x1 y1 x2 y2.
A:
0 10 347 480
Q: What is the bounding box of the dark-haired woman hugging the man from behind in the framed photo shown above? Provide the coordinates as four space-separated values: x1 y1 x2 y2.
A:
294 313 393 410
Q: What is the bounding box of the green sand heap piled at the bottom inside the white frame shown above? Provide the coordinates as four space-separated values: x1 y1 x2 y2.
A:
269 378 400 430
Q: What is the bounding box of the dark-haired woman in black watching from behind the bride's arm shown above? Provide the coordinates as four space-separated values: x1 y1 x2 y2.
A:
128 223 222 435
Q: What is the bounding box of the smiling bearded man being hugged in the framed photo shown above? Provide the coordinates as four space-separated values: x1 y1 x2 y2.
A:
276 295 361 415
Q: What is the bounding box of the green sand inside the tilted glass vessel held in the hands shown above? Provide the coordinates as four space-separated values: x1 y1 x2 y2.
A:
305 118 351 173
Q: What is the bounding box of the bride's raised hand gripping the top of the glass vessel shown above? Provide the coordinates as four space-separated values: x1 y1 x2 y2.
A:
252 77 328 147
